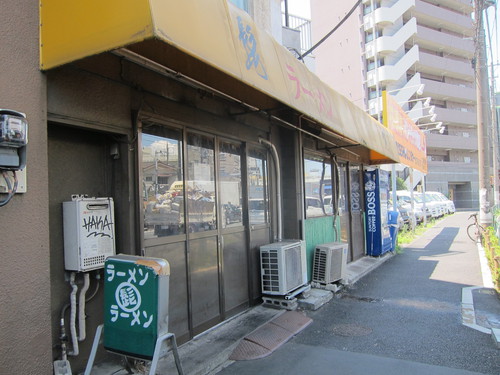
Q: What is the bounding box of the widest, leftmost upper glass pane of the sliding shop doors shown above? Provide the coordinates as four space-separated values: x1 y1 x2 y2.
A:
141 126 185 239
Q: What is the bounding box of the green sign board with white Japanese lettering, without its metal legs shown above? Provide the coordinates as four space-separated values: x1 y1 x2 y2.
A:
104 254 170 359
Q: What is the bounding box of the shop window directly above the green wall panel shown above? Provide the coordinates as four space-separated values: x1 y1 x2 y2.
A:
304 156 333 218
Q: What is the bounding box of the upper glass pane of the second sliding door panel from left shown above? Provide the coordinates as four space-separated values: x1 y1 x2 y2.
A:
186 134 217 232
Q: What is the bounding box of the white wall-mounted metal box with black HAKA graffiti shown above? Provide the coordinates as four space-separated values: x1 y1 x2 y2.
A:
63 197 116 272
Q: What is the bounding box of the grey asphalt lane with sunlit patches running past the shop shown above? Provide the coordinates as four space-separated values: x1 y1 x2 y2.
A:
219 212 500 375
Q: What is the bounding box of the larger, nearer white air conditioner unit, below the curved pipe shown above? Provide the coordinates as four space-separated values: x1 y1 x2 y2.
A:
260 240 307 296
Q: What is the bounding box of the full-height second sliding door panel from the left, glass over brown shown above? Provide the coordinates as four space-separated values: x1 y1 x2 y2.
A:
185 133 222 335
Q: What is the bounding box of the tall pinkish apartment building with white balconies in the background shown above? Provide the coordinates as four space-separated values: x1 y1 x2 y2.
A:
311 0 478 208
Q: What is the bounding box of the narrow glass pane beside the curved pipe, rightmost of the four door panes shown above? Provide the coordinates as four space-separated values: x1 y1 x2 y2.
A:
247 150 269 225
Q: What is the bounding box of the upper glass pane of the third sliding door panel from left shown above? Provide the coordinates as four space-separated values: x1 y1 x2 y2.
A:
219 142 243 228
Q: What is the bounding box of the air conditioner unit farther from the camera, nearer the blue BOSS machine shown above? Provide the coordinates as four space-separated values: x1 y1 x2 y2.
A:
312 242 348 284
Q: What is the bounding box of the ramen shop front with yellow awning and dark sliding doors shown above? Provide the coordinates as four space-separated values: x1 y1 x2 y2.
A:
0 0 406 375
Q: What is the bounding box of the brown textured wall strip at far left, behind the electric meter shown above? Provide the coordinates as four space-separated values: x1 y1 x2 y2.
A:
0 0 52 375
